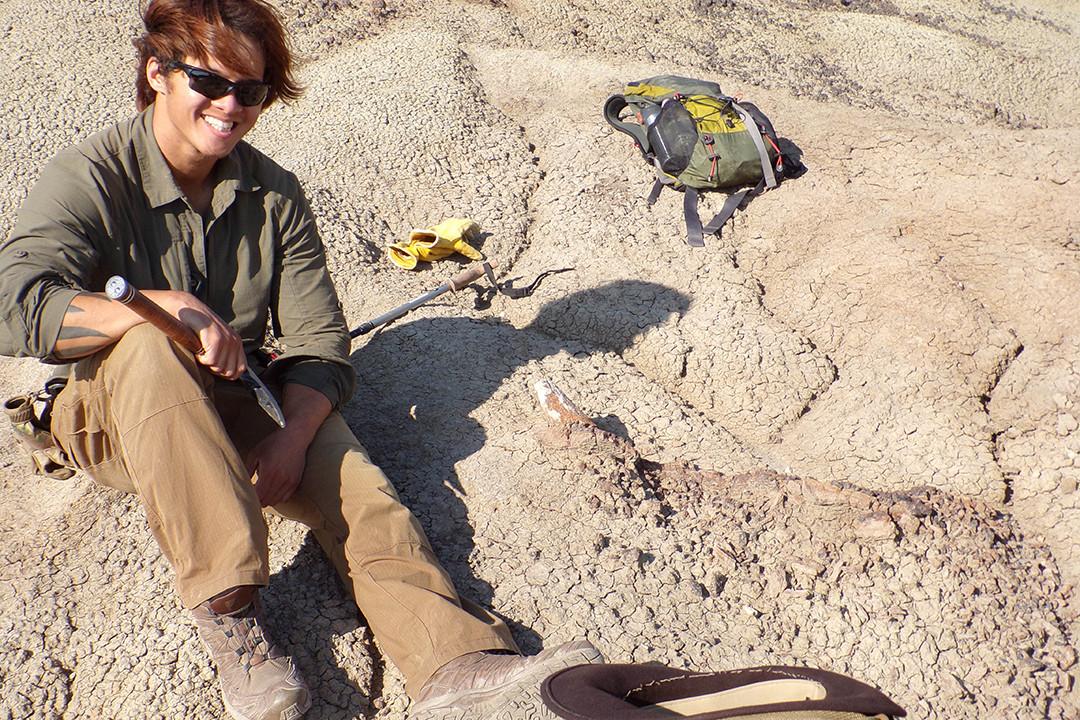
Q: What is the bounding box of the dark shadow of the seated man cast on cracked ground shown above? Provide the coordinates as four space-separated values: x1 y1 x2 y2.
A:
345 281 689 653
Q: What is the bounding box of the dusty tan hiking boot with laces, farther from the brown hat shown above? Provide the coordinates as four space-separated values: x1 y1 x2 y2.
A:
191 599 311 720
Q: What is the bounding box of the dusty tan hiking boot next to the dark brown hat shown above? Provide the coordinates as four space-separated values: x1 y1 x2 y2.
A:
409 640 604 720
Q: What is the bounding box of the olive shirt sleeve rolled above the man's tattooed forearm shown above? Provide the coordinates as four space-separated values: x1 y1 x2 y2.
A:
0 150 102 363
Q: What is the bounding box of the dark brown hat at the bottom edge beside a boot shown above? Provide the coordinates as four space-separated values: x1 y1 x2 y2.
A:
540 665 907 720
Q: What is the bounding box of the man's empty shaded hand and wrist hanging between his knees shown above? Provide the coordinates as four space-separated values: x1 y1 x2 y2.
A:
244 384 333 507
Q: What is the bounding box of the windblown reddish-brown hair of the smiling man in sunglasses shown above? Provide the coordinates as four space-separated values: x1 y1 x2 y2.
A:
134 0 303 110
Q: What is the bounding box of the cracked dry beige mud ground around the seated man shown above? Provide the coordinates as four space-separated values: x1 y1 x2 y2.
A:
0 0 1080 719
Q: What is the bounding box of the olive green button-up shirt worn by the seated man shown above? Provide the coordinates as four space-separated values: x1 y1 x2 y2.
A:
0 106 355 407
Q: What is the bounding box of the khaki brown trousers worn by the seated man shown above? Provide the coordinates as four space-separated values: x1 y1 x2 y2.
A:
52 325 516 696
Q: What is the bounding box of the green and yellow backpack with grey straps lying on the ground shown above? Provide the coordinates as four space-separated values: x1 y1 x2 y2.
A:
604 76 802 247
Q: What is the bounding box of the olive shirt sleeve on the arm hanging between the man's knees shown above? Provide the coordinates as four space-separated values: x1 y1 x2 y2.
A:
271 177 355 408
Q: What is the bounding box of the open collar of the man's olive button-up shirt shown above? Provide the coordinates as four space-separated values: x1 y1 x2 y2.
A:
132 105 259 215
